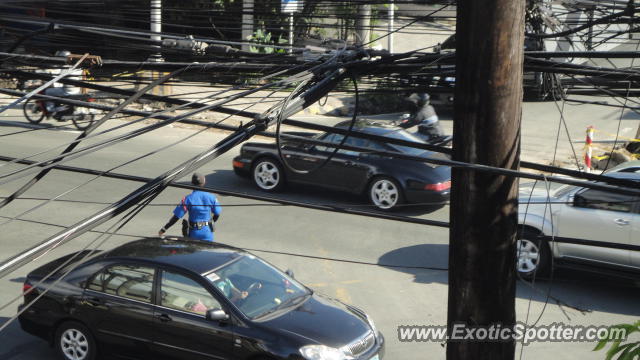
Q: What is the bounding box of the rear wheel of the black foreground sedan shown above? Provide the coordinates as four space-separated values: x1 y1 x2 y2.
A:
55 321 96 360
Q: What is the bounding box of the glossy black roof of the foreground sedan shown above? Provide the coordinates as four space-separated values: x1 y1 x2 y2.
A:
105 238 244 274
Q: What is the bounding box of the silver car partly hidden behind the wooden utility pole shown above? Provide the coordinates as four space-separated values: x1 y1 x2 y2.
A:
517 172 640 278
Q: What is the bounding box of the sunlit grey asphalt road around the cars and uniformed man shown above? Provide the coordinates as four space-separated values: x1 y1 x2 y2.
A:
0 104 640 360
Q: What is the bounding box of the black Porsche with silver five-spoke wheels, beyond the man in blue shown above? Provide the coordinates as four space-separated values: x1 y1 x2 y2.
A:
233 121 451 210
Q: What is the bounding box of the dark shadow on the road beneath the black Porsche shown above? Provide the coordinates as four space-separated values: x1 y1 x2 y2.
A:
199 169 442 216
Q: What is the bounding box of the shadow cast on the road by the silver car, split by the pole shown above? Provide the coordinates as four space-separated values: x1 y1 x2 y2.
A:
378 244 640 316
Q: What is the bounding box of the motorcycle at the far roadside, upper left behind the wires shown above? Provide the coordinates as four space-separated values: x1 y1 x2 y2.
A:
22 92 97 130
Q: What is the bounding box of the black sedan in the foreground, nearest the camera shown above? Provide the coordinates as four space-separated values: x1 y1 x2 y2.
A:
19 238 384 360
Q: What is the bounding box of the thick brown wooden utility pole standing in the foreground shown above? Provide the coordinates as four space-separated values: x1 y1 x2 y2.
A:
447 0 525 360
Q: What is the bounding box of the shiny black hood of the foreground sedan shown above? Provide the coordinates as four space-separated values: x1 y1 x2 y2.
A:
262 293 371 348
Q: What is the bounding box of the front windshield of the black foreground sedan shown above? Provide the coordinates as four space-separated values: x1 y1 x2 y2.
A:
205 255 310 319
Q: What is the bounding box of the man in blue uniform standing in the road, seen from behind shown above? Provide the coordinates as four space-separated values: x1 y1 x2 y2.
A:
158 173 221 241
